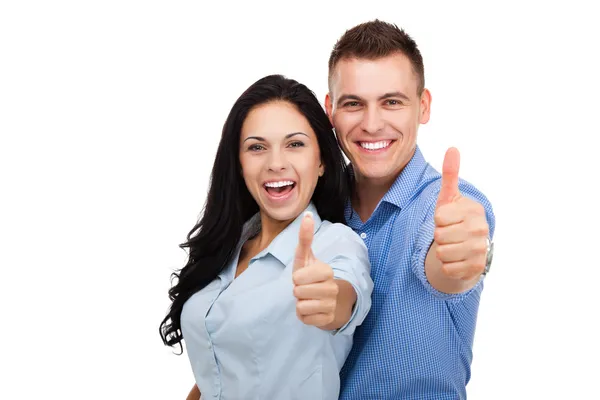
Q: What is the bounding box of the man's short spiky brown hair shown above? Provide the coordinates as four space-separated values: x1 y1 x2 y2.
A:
329 19 425 96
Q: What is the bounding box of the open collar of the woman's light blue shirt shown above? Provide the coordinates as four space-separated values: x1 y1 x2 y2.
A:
239 202 322 265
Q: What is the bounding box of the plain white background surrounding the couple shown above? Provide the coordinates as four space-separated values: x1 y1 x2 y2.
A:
0 0 600 399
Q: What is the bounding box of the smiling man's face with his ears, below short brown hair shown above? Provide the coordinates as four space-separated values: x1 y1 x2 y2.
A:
325 54 431 182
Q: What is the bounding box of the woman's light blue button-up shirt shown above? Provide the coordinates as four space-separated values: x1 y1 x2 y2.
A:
181 203 373 400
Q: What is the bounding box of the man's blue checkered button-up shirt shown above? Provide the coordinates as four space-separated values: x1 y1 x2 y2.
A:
340 147 495 400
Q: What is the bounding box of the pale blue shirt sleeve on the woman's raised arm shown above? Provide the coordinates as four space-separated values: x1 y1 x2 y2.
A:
321 224 373 335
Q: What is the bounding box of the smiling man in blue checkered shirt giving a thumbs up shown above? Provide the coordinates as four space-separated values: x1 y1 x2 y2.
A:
325 20 495 400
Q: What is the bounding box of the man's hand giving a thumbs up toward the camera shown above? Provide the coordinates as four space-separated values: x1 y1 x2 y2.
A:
433 148 489 281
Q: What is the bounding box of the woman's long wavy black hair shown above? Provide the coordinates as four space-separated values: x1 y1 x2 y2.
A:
159 75 349 351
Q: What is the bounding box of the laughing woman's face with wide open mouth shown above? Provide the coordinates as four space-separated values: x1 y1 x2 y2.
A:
240 101 324 221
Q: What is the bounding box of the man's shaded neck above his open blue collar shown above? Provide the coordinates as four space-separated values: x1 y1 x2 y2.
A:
352 174 397 222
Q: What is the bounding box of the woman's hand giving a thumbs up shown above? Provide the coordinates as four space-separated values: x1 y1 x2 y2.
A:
292 213 339 327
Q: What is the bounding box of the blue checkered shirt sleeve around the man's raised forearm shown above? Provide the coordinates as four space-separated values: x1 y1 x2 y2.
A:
411 180 495 302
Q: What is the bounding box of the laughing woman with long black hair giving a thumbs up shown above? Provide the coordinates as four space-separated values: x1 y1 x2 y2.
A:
160 75 373 400
